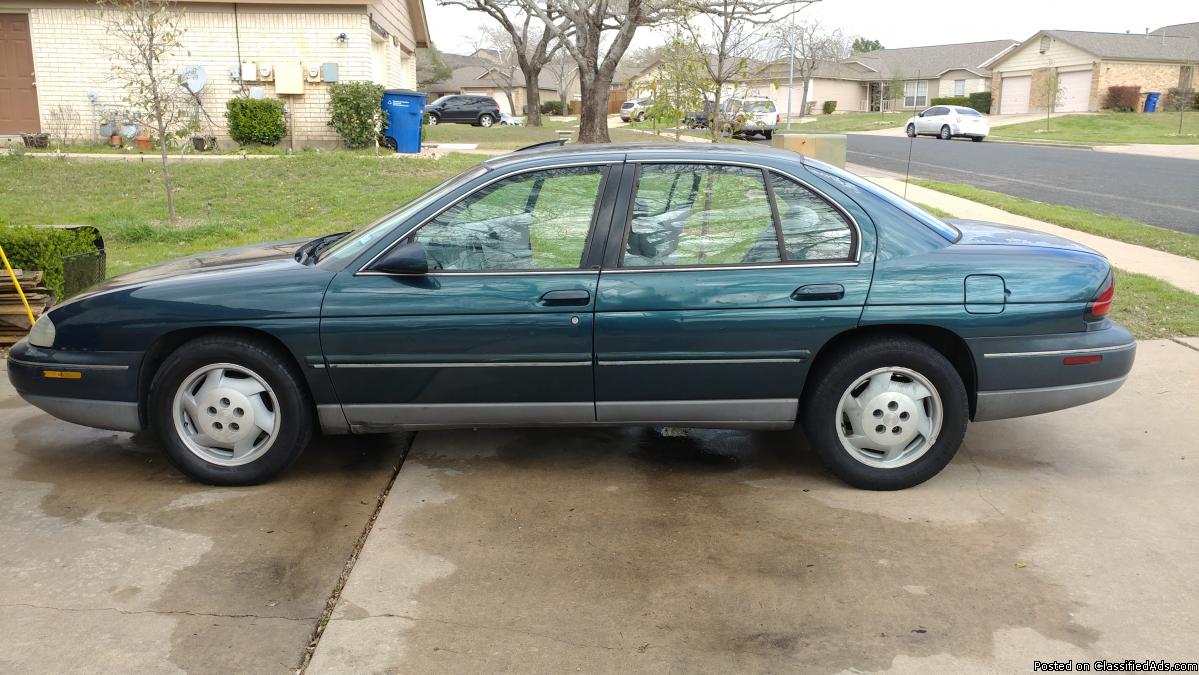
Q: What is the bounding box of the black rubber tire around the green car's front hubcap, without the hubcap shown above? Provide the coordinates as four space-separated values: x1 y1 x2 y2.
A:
146 336 314 486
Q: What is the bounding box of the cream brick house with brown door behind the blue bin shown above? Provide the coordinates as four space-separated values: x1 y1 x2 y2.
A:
0 0 429 146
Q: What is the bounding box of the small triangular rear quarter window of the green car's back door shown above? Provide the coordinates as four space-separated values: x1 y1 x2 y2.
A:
770 174 854 260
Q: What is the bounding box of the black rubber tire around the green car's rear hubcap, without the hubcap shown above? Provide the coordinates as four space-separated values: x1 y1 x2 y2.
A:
800 336 970 490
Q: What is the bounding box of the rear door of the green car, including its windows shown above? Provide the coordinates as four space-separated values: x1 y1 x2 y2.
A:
596 162 872 426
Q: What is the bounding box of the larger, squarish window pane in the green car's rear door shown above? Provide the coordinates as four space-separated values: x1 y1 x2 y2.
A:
622 164 781 267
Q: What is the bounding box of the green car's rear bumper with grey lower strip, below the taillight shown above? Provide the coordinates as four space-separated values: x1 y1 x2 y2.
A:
966 324 1137 422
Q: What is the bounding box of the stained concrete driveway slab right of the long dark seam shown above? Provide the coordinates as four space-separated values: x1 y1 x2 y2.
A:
309 340 1199 673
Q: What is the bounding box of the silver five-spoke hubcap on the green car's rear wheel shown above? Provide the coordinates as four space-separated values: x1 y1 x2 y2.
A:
837 366 944 469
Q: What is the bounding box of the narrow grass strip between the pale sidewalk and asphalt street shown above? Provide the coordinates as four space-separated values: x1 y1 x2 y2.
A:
911 180 1199 259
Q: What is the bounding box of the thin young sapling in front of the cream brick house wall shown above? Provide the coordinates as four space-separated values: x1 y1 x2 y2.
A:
101 0 189 223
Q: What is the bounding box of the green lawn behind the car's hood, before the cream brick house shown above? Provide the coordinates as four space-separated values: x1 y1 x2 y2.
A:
0 152 481 275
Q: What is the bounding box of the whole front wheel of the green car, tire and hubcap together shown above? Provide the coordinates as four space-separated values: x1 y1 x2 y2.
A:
147 337 313 486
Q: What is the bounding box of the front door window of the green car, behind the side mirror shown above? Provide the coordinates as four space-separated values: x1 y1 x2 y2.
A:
409 167 603 272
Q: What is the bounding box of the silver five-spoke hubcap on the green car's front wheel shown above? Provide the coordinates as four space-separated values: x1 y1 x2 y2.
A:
171 363 281 466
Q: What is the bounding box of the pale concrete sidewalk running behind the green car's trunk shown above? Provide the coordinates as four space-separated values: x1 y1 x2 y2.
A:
863 171 1199 294
